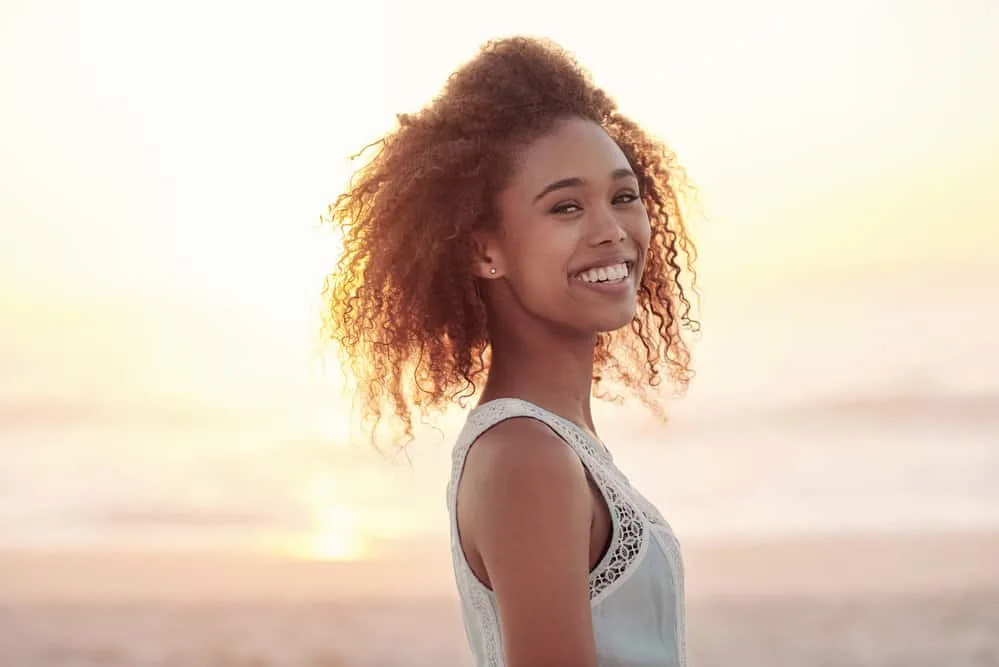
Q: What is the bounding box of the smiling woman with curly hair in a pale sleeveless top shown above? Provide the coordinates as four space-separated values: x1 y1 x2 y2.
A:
327 38 695 667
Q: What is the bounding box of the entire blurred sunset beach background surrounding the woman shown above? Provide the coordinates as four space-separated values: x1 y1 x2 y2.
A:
0 0 999 667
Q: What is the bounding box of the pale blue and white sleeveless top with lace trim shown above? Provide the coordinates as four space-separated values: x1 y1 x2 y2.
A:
447 398 686 667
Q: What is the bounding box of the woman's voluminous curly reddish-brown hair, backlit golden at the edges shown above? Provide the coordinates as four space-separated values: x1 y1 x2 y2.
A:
323 37 698 446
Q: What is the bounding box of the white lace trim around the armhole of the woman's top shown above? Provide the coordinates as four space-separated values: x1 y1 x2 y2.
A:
448 398 661 612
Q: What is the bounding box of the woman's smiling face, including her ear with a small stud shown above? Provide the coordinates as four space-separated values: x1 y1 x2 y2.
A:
479 118 650 334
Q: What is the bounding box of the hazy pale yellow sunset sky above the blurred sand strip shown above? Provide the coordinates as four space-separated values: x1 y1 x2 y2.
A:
0 0 999 558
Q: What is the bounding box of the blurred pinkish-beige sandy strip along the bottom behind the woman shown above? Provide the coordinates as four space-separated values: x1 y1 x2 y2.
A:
0 534 999 667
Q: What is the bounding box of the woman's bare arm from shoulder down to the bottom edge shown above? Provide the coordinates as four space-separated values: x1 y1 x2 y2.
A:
462 418 597 667
